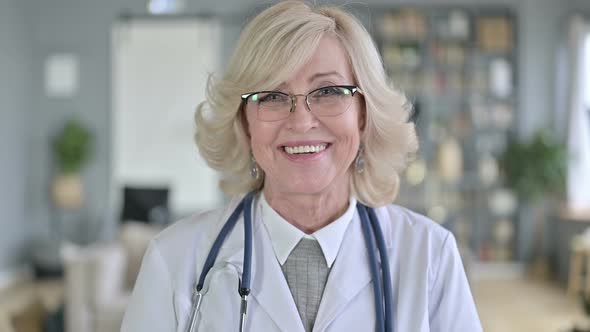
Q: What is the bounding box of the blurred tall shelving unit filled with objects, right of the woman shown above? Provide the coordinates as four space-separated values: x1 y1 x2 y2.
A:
372 6 518 261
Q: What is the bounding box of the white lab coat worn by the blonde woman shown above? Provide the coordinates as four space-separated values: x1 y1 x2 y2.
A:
121 199 482 332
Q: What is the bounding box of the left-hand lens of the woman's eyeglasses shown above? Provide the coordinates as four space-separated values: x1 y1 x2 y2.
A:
247 92 291 121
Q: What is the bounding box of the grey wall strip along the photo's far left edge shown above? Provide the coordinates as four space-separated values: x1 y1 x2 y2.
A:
0 0 31 274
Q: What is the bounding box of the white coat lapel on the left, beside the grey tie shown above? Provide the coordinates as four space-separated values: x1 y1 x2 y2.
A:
251 218 305 332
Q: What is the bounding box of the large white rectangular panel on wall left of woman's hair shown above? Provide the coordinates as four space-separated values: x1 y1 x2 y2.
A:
111 19 223 216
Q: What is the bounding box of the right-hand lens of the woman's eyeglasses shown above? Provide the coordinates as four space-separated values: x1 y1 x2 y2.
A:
307 86 352 116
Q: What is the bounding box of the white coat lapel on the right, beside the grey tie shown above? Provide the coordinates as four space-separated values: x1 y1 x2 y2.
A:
313 212 372 331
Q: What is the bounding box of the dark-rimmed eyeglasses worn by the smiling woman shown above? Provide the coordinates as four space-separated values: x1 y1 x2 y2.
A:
241 85 362 121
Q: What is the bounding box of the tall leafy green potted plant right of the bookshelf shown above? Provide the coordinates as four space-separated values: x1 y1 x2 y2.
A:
500 130 567 277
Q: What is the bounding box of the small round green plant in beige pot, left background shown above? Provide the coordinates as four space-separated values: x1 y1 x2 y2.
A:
51 119 92 209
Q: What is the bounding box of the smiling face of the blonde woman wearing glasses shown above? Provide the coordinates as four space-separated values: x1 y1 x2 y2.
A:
246 35 364 194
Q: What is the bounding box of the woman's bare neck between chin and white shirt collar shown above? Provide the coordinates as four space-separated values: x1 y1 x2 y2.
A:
263 181 350 234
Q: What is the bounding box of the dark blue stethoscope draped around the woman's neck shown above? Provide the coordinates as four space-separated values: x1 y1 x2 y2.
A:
186 192 393 332
